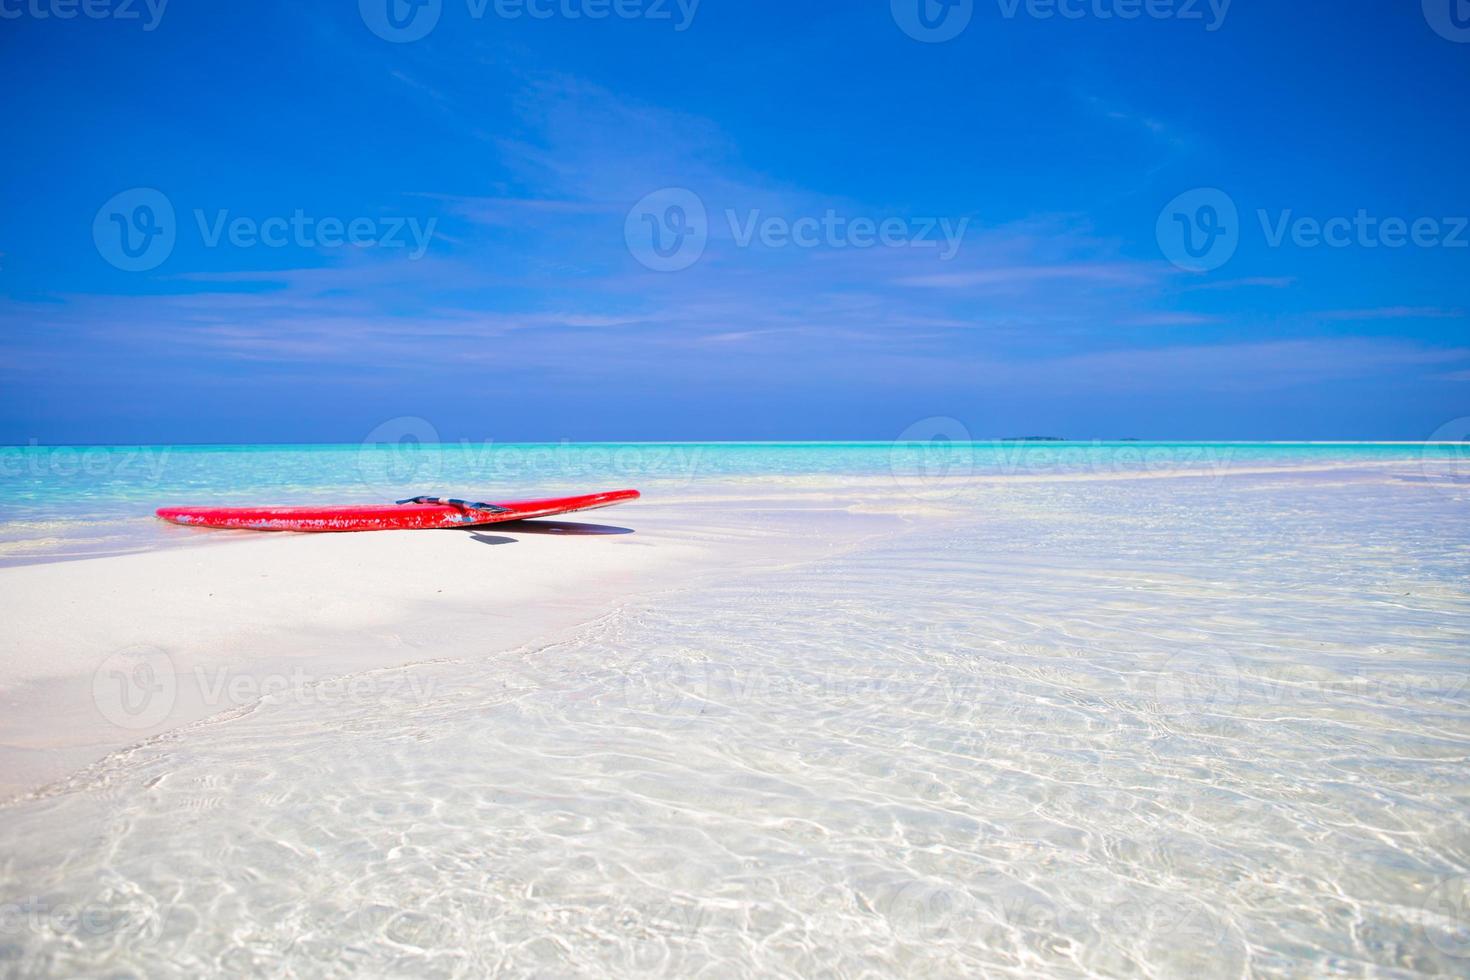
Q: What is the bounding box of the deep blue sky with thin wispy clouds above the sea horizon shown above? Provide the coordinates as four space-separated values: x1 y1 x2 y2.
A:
0 0 1470 444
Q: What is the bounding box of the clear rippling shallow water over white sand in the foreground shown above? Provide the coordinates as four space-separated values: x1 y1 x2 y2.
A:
0 467 1470 977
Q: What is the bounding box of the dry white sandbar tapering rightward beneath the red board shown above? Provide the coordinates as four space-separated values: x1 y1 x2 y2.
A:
0 494 899 798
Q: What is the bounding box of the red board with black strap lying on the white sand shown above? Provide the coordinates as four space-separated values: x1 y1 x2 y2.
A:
156 491 638 532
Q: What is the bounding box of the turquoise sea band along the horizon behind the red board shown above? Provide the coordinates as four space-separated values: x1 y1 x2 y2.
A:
0 440 1470 563
